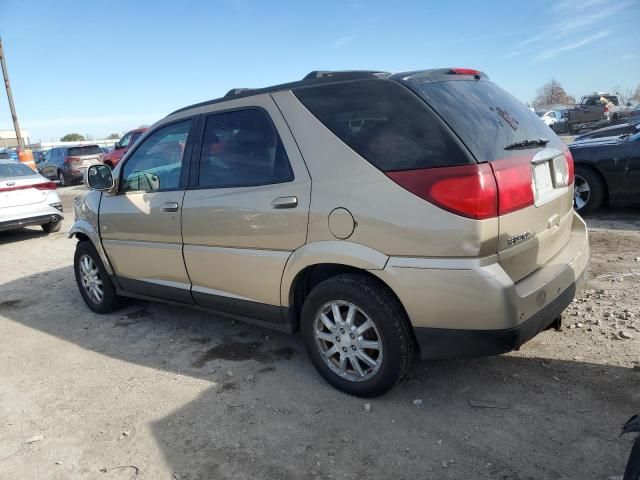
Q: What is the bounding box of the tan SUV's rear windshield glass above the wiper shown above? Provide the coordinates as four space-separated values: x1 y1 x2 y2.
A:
413 80 562 162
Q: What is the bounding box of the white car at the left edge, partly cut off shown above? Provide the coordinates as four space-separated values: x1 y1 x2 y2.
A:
0 160 64 233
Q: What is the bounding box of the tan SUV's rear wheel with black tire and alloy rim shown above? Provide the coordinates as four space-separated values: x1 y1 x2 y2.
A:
301 274 416 397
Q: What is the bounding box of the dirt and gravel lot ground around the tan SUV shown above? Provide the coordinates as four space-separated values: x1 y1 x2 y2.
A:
0 187 640 480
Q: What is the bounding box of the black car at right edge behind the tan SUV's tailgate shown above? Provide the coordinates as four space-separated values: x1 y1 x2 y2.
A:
569 131 640 214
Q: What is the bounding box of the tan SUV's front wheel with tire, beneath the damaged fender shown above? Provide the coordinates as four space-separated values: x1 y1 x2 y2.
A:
73 241 122 313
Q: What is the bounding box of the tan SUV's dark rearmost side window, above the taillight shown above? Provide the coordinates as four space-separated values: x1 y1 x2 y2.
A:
293 80 470 172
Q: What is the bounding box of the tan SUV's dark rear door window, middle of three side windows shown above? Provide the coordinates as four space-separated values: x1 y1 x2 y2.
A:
198 109 293 188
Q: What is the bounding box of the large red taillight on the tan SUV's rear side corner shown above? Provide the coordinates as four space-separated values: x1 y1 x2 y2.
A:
386 163 498 220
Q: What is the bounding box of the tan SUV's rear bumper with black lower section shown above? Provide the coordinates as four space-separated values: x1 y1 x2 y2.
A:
370 214 589 358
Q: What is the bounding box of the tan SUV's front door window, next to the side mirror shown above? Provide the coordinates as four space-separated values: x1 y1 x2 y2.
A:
120 120 191 192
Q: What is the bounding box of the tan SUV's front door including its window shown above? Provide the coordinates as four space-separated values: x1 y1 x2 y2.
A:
100 119 194 303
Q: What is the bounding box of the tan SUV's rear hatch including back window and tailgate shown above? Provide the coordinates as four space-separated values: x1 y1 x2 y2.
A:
394 69 573 282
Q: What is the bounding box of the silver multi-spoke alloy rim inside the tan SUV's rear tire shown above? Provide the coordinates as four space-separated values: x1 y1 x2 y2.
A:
313 300 384 382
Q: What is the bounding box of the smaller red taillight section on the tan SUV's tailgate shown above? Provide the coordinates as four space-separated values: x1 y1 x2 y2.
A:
491 157 534 215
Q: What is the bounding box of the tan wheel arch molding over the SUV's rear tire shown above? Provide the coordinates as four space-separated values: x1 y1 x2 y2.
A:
280 240 389 307
